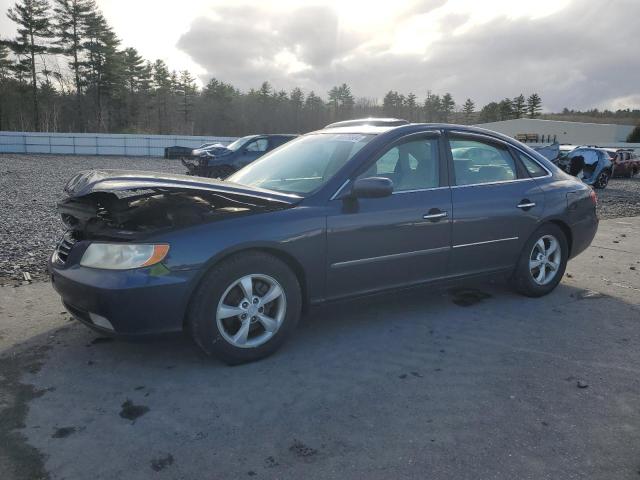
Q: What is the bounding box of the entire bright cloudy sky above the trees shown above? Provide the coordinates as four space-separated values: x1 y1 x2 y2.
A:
0 0 640 111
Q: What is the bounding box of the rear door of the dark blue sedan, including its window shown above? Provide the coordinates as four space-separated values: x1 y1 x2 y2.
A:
447 133 548 275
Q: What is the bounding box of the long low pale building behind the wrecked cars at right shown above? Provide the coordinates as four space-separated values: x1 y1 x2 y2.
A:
476 118 634 147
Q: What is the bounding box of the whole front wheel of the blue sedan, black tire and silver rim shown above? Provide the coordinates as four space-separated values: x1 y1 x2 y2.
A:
187 251 302 365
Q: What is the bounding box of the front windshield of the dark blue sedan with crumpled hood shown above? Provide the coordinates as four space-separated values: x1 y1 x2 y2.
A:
227 133 374 195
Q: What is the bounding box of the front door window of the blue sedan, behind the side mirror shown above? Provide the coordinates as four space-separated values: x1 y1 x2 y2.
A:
358 138 440 192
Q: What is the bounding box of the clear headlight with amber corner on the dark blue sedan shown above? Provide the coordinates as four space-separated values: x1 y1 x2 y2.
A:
80 243 169 270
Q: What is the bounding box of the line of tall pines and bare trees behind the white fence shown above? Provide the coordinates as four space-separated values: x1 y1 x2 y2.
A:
0 0 636 136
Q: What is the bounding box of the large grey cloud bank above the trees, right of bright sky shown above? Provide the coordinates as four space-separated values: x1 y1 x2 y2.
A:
178 0 640 110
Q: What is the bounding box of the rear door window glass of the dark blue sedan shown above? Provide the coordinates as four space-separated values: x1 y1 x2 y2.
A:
449 137 517 185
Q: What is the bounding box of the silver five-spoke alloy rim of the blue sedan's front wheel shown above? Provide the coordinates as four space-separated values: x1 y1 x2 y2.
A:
216 274 287 348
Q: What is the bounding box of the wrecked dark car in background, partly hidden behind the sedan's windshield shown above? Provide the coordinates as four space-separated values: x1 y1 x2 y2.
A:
182 134 296 178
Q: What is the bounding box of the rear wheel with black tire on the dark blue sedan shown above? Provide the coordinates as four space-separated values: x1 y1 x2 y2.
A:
512 223 569 297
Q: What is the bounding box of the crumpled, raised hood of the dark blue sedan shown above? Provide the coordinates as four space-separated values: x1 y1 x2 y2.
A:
64 170 302 205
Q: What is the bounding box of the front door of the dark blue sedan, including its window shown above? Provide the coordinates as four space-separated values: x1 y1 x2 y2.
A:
327 134 451 298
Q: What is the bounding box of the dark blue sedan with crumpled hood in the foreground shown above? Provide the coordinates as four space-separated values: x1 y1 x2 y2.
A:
50 124 598 363
